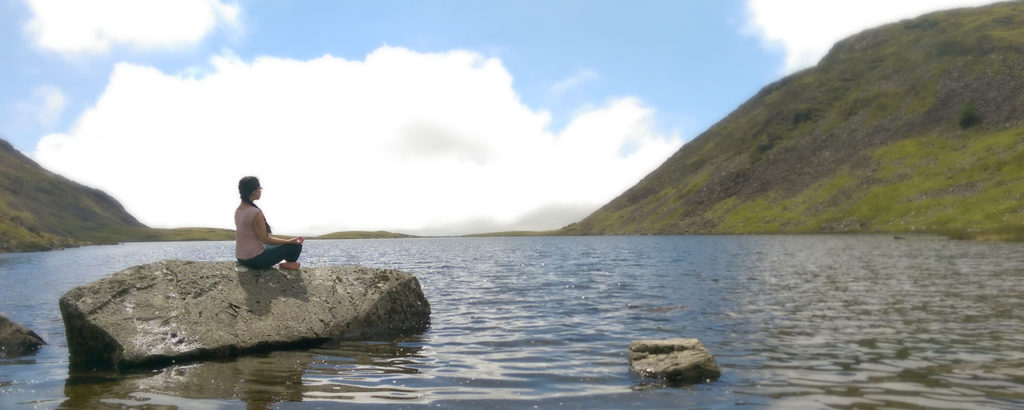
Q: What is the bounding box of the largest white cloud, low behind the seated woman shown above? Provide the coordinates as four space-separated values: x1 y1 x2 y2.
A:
35 47 681 234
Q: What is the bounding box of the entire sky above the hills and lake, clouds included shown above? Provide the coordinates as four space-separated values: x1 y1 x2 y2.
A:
0 0 990 234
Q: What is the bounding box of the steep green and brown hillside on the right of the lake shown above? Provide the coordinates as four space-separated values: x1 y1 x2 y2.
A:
562 2 1024 239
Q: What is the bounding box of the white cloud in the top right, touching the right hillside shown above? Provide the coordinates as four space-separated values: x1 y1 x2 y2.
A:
746 0 996 73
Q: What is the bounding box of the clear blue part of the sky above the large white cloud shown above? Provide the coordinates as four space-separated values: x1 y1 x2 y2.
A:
0 0 782 152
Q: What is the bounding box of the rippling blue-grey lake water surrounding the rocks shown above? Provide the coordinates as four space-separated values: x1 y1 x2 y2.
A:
0 235 1024 409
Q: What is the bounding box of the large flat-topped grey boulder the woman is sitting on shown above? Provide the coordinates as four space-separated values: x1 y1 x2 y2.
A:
60 260 430 370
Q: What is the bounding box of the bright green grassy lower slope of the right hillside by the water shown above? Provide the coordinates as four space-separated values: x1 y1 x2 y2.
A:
711 127 1024 233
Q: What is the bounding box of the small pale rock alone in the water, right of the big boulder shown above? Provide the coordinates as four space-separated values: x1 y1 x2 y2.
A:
630 338 722 383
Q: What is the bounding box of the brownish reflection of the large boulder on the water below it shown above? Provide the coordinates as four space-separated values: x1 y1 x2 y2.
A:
61 342 420 408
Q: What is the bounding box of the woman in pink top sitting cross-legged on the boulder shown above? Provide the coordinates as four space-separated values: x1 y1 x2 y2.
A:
234 176 305 270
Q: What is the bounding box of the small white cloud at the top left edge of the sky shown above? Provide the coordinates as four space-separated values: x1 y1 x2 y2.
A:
25 0 240 53
